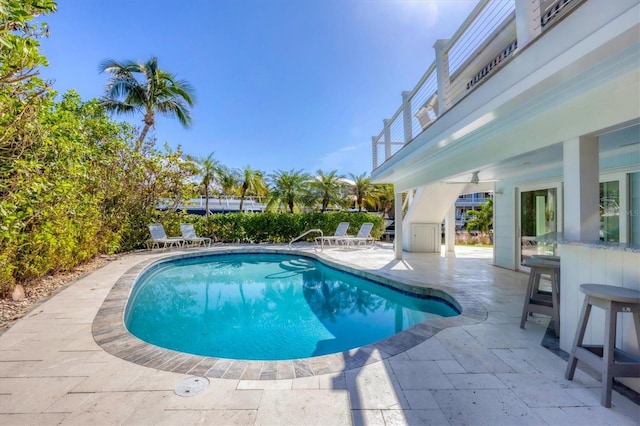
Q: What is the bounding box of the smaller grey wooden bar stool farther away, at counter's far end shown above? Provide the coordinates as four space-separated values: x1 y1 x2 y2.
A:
520 258 560 336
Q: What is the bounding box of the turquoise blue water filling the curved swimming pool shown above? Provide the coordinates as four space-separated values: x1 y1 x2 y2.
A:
125 254 459 360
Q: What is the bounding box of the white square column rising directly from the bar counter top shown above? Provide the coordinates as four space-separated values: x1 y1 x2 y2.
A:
563 136 600 241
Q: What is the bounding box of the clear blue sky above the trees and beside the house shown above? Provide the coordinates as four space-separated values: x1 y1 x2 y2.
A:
38 0 476 175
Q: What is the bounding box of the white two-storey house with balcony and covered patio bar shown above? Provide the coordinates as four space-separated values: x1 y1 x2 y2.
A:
371 0 640 390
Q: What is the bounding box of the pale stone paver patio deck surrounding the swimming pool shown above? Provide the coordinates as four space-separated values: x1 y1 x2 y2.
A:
0 245 640 425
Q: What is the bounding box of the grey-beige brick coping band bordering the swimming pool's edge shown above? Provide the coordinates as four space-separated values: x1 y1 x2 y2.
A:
92 247 488 380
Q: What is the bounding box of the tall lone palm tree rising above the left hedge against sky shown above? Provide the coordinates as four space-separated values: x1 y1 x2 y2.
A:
99 57 195 151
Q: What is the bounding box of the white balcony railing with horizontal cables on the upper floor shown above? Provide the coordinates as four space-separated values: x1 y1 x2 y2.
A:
372 0 586 169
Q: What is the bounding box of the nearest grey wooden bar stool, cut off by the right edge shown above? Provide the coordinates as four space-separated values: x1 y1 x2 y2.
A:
564 284 640 408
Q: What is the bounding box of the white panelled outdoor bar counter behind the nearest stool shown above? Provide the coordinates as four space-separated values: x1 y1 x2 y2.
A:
555 236 640 392
